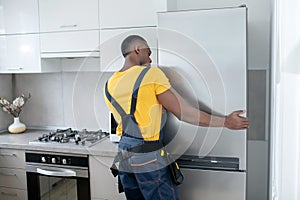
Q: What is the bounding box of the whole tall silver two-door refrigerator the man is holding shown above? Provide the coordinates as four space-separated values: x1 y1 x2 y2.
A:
157 7 247 200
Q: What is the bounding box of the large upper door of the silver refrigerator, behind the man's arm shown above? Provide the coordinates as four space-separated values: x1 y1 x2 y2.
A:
157 7 247 169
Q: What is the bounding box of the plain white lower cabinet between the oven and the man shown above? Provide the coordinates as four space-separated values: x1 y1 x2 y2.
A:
90 156 126 200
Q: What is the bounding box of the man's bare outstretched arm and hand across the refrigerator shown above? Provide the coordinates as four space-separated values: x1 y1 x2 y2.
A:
157 88 249 130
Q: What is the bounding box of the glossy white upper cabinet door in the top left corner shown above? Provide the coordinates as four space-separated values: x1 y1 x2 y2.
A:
0 0 39 34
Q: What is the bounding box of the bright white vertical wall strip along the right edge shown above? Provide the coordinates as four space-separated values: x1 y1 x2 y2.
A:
271 0 300 200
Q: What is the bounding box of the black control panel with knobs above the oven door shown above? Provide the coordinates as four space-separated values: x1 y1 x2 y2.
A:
25 152 88 167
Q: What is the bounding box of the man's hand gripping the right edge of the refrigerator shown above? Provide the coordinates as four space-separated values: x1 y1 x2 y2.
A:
224 110 249 130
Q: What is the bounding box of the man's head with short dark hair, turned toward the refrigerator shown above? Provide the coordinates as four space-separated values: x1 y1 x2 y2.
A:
121 35 152 65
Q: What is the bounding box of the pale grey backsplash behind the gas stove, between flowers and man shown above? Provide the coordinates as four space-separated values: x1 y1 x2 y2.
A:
15 72 111 130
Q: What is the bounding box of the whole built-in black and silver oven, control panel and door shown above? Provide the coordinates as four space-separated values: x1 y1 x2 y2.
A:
25 152 91 200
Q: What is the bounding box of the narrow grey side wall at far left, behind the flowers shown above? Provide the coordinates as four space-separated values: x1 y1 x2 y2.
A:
0 75 13 131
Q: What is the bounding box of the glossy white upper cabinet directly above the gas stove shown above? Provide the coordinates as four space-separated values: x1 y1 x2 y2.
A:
39 0 99 58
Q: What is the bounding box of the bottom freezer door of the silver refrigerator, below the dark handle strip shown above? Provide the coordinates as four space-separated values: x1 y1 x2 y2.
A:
178 168 246 200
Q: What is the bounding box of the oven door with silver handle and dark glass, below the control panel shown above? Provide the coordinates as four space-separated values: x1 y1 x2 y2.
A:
26 164 90 200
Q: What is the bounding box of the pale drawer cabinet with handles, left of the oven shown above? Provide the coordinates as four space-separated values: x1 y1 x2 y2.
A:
0 149 27 200
